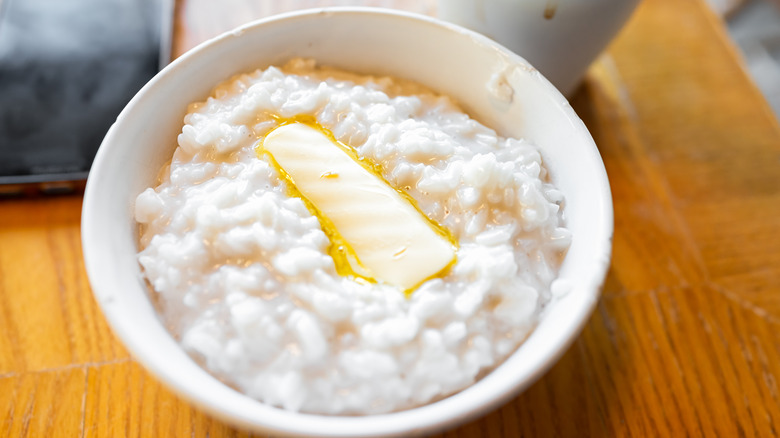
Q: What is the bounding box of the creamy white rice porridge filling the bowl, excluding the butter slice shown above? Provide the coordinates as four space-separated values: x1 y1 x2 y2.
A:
135 59 571 415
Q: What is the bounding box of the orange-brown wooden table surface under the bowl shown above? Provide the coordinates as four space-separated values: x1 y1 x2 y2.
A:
0 0 780 437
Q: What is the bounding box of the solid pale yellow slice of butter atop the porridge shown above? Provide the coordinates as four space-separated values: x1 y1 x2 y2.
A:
262 122 456 290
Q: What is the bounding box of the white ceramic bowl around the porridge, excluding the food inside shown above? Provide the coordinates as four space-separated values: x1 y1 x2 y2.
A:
82 8 612 436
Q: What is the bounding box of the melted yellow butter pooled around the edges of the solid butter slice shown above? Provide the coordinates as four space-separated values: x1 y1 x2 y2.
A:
255 115 458 297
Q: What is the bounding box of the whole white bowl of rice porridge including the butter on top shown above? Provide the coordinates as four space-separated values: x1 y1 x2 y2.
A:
82 8 612 436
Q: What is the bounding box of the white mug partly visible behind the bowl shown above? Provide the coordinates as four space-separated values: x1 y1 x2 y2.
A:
438 0 639 96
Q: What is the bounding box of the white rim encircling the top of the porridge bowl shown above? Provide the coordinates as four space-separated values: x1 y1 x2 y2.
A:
81 7 614 436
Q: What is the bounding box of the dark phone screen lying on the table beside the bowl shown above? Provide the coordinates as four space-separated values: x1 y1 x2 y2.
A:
0 0 167 184
